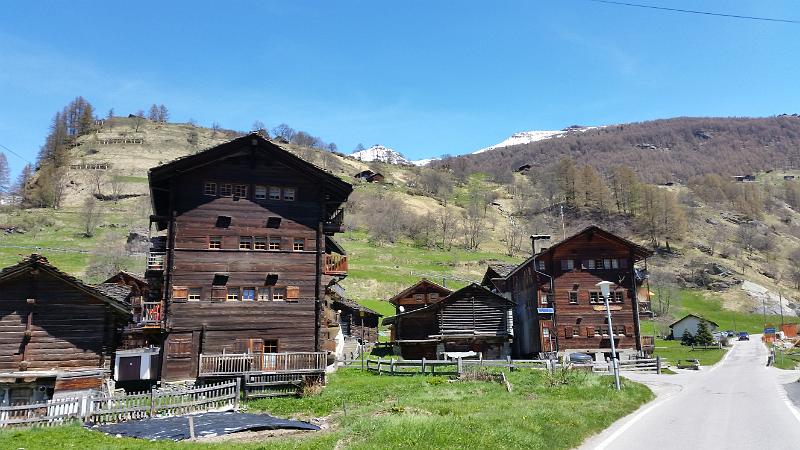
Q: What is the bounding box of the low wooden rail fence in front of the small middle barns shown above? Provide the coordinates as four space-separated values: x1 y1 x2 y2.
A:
364 358 555 375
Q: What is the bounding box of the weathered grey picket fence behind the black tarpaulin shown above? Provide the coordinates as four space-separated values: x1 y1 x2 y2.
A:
0 379 240 428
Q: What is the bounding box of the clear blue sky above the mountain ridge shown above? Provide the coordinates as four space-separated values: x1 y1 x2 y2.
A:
0 0 800 173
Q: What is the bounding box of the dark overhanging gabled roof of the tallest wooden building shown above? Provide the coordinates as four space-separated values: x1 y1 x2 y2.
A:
148 132 353 229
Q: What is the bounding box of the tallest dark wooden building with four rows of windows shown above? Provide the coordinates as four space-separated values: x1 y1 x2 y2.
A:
147 133 352 380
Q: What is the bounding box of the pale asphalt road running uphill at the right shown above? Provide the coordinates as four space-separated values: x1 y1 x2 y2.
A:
580 336 800 450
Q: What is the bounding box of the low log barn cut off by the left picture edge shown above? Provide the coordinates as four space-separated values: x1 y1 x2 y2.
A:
0 254 131 406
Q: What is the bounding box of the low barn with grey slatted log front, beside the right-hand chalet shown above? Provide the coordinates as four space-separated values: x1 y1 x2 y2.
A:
383 283 513 359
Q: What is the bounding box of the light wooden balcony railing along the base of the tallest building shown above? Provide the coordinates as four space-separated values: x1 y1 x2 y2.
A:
197 352 327 377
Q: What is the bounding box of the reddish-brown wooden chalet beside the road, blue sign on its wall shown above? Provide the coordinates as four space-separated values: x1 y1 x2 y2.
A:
484 226 652 357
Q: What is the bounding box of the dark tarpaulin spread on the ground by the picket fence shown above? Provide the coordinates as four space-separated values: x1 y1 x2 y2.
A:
91 411 320 441
